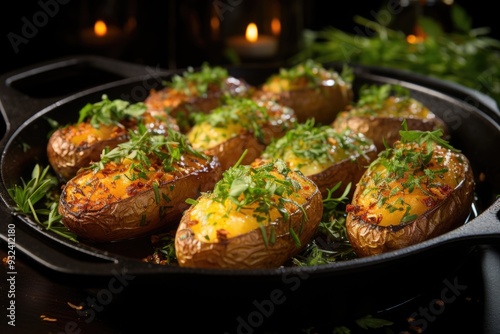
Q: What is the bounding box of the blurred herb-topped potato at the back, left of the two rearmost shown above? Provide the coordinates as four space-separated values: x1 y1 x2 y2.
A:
144 63 253 133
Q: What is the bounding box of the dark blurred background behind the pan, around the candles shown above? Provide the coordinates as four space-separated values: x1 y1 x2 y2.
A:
0 0 499 73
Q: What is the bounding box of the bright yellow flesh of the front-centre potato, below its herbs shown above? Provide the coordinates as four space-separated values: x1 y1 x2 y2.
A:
190 174 316 243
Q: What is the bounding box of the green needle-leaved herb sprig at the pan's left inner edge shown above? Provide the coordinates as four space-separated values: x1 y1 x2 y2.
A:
8 164 78 242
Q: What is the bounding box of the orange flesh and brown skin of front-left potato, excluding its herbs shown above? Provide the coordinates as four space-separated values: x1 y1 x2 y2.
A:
59 156 222 243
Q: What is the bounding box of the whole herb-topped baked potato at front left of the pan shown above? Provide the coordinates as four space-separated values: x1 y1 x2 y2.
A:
58 126 222 243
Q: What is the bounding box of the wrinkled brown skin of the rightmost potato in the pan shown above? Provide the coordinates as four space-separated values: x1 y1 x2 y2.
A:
346 145 475 257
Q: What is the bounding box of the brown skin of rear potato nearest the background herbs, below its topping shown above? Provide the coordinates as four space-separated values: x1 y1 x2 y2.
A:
254 83 353 125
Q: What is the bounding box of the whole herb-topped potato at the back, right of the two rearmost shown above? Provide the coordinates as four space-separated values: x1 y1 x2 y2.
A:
253 60 353 125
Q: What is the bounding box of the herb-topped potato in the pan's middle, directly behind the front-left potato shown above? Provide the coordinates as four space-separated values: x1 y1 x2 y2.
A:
187 98 296 170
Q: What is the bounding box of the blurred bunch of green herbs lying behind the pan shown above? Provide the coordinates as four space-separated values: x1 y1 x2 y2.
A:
290 3 500 103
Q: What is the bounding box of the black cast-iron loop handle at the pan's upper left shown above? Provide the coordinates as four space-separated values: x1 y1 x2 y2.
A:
0 55 158 137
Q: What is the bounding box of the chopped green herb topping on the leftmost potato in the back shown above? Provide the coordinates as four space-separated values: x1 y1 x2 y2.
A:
78 94 147 128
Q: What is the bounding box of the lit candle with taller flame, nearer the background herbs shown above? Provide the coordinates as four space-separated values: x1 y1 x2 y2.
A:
227 23 278 58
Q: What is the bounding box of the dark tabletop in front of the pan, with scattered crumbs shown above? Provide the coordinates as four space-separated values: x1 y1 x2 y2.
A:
0 234 492 334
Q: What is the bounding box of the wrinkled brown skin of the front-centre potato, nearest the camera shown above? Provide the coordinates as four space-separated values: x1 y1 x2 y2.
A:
175 173 323 269
